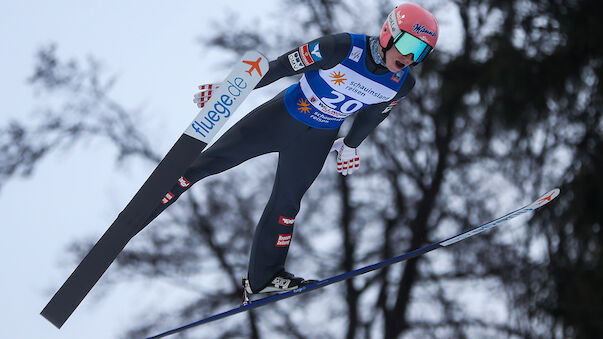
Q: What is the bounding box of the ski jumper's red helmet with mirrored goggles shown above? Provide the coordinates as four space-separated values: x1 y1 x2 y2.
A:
379 4 438 62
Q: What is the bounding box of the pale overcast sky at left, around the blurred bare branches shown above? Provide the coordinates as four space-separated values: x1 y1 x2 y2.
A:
0 0 282 339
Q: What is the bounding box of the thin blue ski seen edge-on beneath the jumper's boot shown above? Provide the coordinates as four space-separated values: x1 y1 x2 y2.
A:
147 188 560 339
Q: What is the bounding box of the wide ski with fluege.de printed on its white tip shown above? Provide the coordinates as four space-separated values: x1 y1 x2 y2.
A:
40 51 268 328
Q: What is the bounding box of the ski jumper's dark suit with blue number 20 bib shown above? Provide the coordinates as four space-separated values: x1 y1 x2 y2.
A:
141 33 415 291
